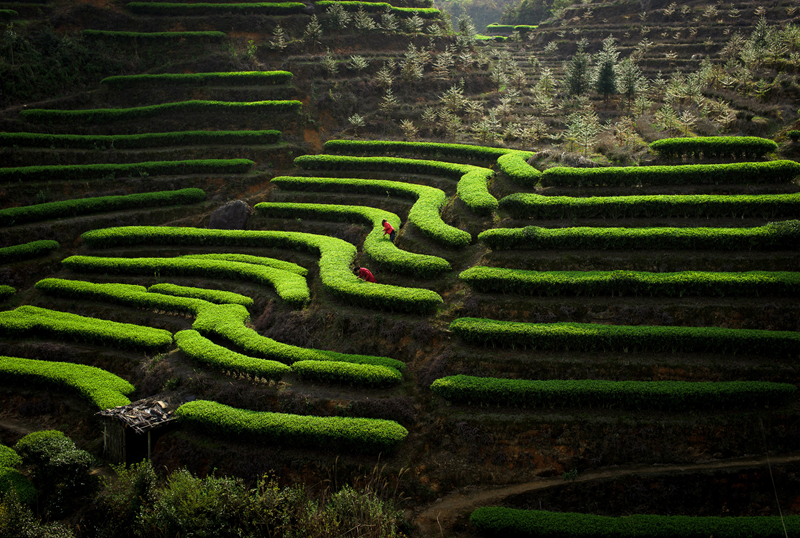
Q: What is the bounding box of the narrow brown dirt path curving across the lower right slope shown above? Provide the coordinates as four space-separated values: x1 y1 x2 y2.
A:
414 454 800 537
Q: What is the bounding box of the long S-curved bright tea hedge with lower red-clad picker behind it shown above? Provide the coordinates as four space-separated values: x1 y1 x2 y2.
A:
81 226 443 313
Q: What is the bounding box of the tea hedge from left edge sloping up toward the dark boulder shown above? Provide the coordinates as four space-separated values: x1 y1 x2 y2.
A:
0 189 206 226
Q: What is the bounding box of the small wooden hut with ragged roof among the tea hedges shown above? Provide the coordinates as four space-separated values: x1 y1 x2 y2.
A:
97 398 178 465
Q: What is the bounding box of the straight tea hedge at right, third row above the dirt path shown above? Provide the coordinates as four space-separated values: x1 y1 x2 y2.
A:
458 267 800 297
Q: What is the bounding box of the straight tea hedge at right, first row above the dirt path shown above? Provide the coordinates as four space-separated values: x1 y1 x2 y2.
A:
431 375 797 412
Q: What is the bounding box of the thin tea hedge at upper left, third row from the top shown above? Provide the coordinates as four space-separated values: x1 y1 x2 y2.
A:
100 71 294 88
